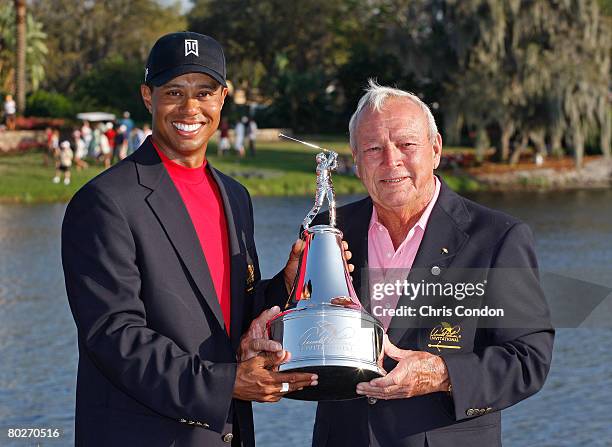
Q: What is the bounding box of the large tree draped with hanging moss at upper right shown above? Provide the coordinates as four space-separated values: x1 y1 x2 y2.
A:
444 0 610 167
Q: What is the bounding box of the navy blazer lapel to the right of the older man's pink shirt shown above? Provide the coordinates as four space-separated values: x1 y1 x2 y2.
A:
387 179 470 345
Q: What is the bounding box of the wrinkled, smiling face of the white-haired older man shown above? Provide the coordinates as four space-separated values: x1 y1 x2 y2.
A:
353 98 442 210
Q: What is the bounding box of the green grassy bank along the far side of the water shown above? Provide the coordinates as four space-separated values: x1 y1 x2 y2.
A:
0 138 478 203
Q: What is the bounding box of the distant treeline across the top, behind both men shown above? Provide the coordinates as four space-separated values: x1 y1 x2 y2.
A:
0 0 612 164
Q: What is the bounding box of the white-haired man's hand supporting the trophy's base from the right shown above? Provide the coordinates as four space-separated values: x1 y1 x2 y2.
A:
357 335 450 399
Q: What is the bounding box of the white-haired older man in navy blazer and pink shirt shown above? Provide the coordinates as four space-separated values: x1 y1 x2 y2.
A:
313 81 554 447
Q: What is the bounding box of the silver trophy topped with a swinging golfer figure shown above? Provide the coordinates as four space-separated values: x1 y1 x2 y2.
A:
268 134 384 401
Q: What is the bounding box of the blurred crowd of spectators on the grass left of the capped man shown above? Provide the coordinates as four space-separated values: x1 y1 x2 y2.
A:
44 112 151 185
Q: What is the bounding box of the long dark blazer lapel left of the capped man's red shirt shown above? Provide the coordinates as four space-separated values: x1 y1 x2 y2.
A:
133 137 225 328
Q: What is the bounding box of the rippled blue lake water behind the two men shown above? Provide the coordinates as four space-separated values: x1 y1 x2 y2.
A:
0 190 612 447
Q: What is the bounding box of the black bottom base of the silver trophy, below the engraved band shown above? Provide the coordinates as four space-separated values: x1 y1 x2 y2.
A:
280 360 383 401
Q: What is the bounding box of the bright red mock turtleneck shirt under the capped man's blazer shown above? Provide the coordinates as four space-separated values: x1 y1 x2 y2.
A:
153 143 231 334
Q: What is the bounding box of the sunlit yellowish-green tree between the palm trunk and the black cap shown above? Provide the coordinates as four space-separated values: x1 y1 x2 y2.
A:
29 0 186 94
